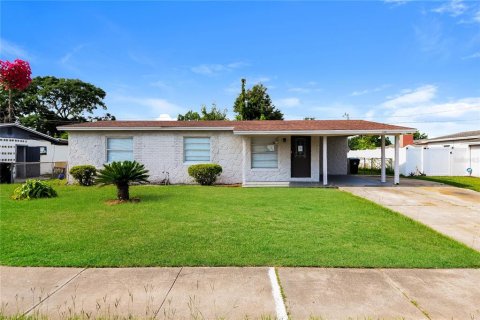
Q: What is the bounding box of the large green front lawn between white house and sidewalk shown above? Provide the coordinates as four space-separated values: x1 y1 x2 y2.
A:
0 185 480 268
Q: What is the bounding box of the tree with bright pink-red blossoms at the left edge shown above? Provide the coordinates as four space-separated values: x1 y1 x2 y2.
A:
0 59 32 122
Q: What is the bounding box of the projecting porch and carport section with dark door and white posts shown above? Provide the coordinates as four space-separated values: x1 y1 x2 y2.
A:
234 120 415 186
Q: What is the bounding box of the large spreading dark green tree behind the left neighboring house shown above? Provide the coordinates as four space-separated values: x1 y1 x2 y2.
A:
0 77 115 136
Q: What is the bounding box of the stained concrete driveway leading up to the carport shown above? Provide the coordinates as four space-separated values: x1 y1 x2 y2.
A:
340 179 480 251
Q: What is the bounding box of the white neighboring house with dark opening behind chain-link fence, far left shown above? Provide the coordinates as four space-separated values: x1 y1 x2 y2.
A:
0 123 68 182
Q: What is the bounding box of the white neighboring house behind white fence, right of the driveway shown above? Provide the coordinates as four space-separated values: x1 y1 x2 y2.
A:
406 130 480 177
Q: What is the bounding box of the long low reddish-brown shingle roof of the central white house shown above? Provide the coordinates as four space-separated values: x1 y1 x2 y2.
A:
58 120 415 134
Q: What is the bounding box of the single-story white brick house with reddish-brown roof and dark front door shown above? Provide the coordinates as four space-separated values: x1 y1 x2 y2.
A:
59 120 415 186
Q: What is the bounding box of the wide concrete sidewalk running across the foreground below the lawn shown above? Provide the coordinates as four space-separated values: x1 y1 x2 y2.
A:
0 267 480 319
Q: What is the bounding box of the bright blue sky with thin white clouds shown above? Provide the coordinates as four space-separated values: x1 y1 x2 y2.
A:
0 0 480 137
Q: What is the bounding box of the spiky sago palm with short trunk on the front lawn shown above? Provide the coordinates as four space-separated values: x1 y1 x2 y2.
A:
96 161 148 200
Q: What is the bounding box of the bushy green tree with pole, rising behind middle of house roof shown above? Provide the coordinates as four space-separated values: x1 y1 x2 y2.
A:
233 79 283 120
